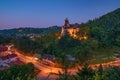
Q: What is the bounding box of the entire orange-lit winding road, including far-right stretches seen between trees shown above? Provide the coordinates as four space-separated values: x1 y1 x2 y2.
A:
15 50 120 80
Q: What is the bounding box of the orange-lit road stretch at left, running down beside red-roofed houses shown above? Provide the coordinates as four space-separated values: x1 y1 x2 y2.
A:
15 51 61 80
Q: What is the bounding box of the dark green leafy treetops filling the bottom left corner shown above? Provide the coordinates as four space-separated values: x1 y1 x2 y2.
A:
0 63 36 80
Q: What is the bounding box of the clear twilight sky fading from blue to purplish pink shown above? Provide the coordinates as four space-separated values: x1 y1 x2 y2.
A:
0 0 120 29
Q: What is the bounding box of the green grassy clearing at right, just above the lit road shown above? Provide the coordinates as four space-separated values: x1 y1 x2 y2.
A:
88 46 120 64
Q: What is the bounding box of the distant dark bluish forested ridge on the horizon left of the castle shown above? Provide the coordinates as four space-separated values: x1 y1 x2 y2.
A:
0 26 61 35
